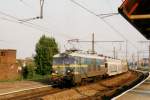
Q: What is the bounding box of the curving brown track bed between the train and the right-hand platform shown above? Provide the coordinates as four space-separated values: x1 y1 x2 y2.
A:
42 71 147 100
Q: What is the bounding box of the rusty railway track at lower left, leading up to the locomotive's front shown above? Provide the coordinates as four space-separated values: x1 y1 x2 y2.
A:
0 86 66 100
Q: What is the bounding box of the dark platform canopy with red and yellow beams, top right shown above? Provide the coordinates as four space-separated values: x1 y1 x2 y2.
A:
118 0 150 40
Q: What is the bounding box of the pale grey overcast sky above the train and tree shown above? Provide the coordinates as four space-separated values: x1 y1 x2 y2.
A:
0 0 145 58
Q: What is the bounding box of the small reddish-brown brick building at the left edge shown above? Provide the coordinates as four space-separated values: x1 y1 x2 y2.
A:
0 49 19 80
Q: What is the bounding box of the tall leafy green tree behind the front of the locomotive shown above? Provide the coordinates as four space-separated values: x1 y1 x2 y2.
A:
34 35 59 75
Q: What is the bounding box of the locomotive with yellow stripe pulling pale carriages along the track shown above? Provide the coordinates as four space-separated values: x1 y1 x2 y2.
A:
50 51 128 86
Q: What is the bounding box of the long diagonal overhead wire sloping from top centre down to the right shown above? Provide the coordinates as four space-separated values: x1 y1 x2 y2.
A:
70 0 138 49
